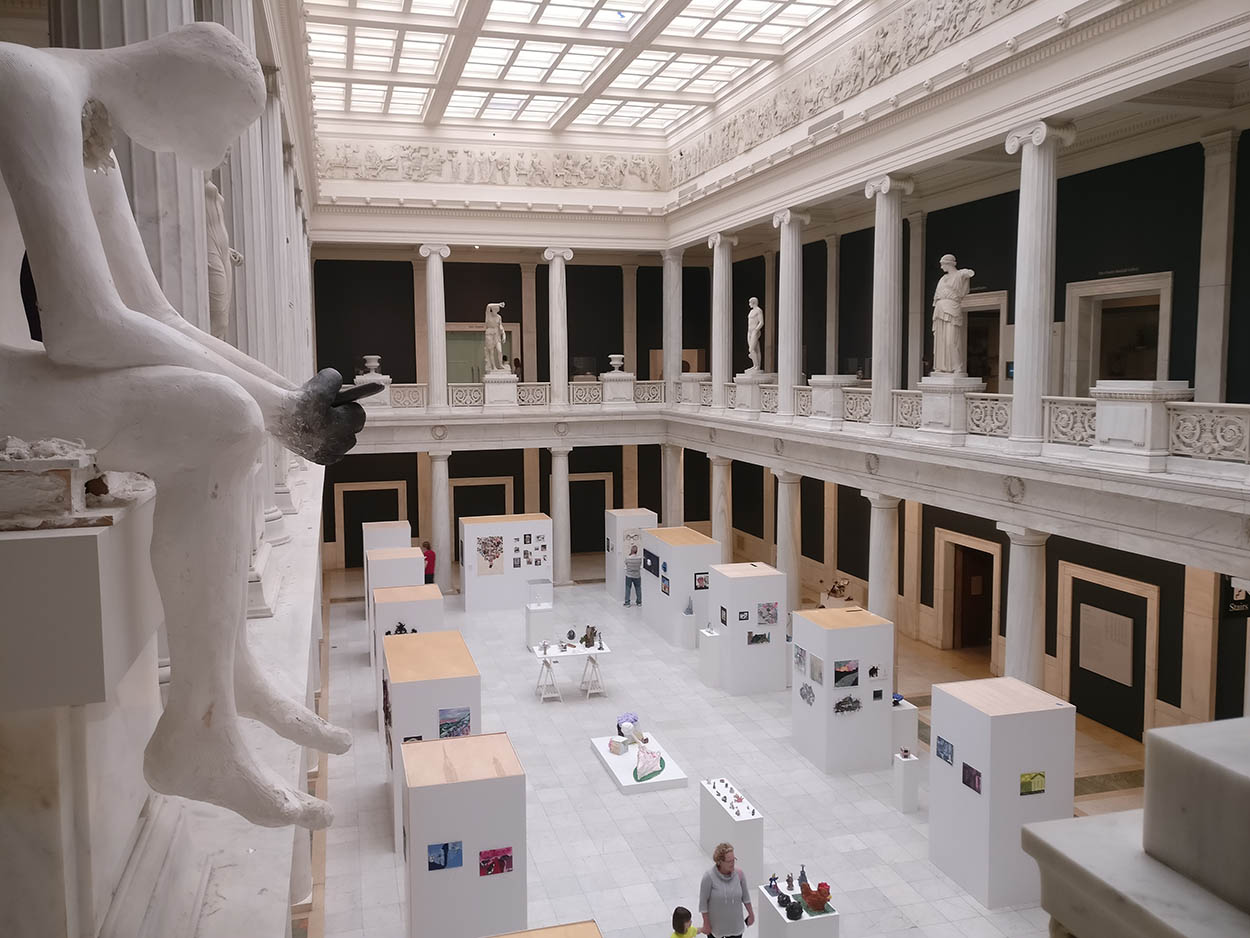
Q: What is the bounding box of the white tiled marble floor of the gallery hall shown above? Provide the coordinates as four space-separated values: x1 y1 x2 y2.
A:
325 583 1048 938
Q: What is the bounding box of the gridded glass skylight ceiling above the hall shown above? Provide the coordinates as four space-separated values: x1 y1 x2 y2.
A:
304 0 855 136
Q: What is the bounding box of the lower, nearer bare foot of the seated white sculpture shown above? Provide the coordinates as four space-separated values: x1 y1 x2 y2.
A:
144 707 334 830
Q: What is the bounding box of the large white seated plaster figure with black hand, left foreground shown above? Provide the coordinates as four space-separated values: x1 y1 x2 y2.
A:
0 23 374 828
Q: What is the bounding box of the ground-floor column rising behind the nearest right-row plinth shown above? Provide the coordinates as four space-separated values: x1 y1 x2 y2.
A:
999 524 1050 687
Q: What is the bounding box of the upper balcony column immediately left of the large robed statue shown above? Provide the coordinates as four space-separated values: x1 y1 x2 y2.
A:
864 175 913 432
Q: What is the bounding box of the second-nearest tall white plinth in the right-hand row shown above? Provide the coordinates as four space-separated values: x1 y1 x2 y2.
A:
790 605 894 772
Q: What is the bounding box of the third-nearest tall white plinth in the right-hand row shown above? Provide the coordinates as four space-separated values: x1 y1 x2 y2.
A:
708 563 790 694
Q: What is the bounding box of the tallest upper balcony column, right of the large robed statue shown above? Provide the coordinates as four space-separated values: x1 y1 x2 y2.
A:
1006 120 1075 453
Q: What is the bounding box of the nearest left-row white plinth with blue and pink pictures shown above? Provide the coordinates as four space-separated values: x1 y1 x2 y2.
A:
404 733 528 938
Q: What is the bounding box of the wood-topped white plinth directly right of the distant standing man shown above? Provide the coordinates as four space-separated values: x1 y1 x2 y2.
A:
643 527 720 648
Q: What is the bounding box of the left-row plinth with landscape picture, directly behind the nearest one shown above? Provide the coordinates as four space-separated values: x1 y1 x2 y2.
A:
381 632 481 852
